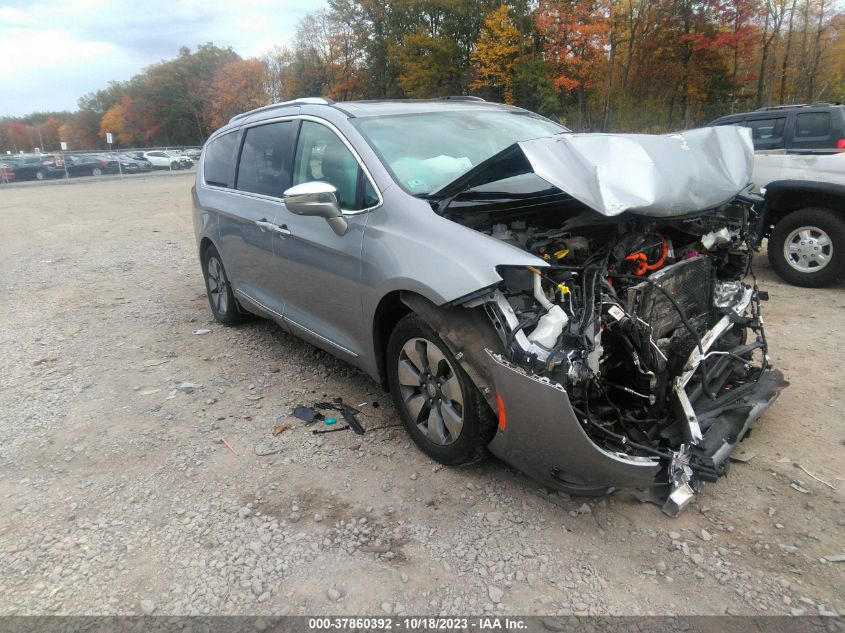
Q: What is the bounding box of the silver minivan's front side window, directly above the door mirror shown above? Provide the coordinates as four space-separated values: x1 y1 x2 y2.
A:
293 121 372 211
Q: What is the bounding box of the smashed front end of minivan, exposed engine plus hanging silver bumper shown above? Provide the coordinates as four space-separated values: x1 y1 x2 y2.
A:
440 127 787 516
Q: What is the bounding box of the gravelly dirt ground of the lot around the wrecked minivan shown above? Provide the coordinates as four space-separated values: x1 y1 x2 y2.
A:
0 174 845 615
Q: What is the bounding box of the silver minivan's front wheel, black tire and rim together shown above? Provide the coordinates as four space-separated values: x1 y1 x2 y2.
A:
387 314 496 466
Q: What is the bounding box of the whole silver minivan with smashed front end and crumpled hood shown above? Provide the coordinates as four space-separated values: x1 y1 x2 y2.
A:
193 97 786 515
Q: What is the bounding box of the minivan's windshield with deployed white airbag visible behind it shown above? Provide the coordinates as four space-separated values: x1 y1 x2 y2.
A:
353 110 569 195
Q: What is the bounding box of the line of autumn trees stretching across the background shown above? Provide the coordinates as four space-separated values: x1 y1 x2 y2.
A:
0 0 845 151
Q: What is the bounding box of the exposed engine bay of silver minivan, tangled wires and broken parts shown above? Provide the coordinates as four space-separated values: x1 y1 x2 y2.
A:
458 196 770 511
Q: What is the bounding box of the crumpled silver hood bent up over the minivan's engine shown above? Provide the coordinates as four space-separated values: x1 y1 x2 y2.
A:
441 126 754 217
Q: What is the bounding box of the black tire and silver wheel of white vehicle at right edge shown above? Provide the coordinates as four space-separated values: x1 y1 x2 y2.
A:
768 207 845 288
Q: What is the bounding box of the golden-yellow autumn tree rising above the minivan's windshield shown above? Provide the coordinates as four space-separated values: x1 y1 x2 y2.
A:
470 4 522 103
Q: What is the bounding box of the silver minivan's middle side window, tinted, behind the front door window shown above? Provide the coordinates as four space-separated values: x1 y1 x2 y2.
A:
237 121 297 198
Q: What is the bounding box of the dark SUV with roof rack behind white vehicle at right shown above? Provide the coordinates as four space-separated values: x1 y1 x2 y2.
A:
710 103 845 152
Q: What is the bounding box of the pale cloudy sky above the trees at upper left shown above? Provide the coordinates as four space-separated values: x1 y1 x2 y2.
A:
0 0 325 116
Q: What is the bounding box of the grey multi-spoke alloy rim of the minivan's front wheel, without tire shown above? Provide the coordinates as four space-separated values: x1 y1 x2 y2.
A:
398 338 464 446
